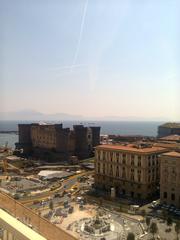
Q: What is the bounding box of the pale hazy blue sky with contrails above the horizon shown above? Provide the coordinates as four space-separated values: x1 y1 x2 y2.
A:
0 0 180 121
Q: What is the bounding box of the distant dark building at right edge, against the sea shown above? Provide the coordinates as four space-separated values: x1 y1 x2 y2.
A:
158 123 180 138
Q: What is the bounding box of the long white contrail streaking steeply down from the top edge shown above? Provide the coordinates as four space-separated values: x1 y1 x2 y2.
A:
70 0 89 72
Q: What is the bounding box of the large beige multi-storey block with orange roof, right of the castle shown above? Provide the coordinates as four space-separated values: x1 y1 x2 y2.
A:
95 144 167 199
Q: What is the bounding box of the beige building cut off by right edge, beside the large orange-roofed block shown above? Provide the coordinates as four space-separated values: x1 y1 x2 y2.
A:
160 152 180 208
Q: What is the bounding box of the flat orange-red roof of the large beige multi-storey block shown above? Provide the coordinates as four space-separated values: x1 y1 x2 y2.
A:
96 144 166 153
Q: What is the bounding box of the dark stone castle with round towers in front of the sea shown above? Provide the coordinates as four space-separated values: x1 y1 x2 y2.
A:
16 123 100 160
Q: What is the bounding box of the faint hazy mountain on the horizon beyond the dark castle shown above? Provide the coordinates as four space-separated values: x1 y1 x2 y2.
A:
0 110 83 121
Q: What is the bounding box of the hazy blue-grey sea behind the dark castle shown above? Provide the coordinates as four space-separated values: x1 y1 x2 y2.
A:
0 121 163 148
